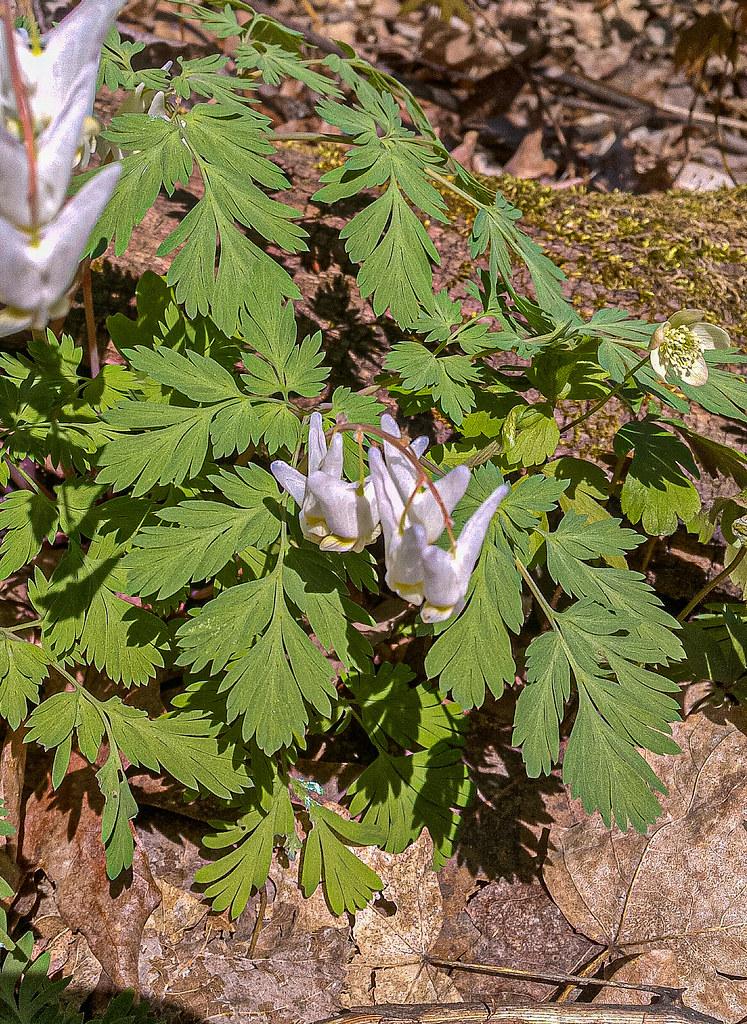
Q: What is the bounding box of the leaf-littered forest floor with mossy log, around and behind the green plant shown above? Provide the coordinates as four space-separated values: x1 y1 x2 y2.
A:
4 0 747 1024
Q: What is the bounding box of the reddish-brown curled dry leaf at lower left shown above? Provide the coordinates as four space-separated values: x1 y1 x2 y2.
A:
23 754 161 988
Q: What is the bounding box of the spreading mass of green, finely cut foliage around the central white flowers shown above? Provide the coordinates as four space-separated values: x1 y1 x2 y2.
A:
0 0 747 937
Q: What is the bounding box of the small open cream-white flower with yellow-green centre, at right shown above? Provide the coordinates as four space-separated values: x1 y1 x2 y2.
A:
651 309 730 387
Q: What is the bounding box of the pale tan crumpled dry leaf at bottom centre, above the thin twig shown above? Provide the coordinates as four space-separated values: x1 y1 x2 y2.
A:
347 831 462 1006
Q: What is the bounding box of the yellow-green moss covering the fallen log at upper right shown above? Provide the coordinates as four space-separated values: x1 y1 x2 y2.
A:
309 144 747 342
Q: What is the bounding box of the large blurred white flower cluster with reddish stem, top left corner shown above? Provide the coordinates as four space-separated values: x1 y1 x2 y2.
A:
0 0 122 336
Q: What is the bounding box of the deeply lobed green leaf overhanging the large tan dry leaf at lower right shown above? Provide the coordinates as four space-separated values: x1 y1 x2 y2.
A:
512 598 679 831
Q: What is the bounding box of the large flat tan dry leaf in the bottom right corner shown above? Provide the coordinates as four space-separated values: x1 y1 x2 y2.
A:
545 711 747 1022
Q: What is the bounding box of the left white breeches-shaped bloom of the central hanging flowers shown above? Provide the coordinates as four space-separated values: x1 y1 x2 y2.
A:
269 413 380 551
